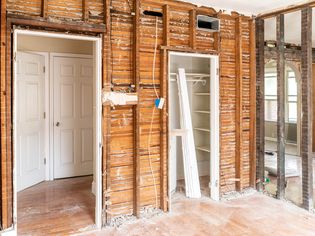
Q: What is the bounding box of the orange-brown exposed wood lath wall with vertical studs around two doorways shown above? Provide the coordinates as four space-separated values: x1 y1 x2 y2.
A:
1 0 256 229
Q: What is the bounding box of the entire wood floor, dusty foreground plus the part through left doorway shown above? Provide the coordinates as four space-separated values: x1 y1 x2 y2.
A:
18 174 315 236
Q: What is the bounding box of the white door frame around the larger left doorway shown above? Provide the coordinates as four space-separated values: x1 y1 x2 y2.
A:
12 29 102 231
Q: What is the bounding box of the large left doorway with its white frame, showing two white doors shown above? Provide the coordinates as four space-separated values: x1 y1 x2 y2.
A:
13 29 102 234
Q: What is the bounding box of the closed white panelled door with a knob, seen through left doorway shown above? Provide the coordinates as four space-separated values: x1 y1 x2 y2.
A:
53 57 93 178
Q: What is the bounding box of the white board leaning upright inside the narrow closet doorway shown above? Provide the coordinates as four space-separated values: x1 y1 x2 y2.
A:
177 68 201 198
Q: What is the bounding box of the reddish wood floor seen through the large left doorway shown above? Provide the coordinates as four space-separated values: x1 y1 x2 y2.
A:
17 176 95 236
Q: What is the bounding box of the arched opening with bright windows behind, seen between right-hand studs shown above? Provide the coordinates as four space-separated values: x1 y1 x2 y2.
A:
265 60 302 205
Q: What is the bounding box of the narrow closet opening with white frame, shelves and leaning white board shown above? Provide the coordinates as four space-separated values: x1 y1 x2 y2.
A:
168 52 220 208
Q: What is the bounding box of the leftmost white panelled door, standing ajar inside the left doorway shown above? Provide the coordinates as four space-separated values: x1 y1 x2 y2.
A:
16 52 45 191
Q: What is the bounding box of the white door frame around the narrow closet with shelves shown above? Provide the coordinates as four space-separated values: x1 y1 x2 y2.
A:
168 51 220 209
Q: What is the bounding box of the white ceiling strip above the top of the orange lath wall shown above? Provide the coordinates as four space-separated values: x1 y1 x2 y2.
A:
181 0 308 15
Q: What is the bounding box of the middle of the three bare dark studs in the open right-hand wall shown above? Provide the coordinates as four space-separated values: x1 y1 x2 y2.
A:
277 14 285 199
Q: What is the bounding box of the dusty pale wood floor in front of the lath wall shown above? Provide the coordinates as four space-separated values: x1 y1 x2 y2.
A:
86 193 315 236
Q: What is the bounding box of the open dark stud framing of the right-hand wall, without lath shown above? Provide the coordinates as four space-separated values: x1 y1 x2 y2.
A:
256 4 314 210
